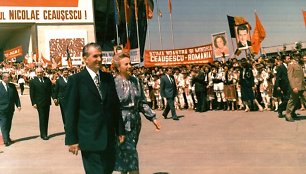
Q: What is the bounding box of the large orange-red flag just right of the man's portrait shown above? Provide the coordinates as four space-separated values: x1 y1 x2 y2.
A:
252 13 266 54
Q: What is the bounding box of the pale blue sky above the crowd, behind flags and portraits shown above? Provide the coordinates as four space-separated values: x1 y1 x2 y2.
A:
146 0 306 50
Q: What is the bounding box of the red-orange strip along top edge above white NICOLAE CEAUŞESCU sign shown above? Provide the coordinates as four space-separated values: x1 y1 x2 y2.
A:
0 0 79 7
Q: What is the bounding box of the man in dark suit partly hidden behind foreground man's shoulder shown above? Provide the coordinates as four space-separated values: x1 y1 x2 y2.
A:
53 68 69 125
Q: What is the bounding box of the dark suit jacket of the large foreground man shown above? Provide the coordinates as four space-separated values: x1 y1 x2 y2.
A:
65 69 124 151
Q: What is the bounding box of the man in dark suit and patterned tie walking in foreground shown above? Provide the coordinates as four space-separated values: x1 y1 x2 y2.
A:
64 43 124 174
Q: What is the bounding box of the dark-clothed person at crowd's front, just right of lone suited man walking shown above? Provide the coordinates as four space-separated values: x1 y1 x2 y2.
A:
191 65 207 112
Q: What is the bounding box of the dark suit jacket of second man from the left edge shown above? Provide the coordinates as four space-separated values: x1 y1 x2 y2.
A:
30 77 52 106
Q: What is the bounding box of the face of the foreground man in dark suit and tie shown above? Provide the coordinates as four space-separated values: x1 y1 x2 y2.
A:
85 47 102 72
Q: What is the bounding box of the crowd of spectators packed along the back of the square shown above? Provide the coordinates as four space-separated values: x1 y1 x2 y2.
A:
0 51 306 116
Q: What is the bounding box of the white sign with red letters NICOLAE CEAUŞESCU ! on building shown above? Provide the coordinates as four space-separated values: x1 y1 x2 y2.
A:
0 0 94 23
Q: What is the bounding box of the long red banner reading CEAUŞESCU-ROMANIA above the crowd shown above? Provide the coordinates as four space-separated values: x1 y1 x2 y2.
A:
144 44 213 67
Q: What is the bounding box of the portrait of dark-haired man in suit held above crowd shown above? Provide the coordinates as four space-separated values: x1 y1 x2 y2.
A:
236 24 252 50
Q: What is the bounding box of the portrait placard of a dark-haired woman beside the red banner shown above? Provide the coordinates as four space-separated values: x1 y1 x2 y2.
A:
212 32 229 58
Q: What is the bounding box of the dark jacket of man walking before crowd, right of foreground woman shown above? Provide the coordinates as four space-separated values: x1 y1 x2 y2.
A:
160 75 177 98
